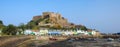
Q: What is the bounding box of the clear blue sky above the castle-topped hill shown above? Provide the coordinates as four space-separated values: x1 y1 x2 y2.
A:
0 0 120 33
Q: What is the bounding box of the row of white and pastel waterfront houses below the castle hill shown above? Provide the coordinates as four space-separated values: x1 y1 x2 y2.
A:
24 29 100 36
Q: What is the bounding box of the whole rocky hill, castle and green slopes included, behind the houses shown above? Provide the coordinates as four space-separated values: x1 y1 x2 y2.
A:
27 12 87 30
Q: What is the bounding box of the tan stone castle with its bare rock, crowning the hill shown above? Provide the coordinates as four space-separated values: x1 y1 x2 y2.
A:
32 12 74 28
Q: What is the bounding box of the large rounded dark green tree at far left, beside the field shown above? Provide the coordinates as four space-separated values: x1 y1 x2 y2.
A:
2 24 18 35
